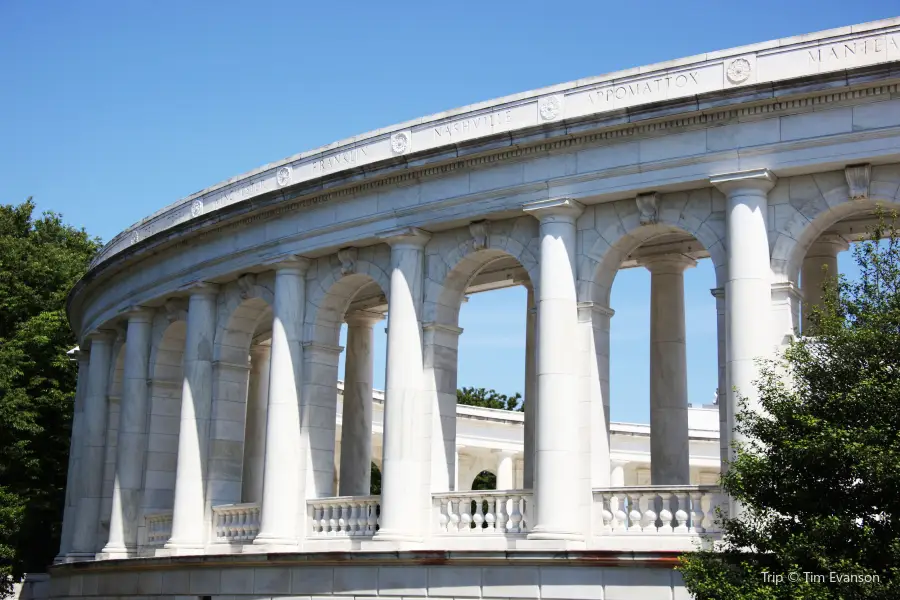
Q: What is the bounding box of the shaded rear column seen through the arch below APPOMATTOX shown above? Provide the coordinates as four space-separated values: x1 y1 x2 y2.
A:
642 254 697 485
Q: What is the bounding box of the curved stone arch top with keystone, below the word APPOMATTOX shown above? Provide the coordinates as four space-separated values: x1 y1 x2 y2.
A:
578 188 728 307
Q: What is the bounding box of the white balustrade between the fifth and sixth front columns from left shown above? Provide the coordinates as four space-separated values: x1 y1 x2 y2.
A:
306 496 381 537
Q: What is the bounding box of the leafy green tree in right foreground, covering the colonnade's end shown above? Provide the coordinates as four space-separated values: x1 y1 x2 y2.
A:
679 218 900 600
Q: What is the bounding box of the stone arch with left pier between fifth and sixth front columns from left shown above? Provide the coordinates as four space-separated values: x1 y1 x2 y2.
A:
303 245 390 498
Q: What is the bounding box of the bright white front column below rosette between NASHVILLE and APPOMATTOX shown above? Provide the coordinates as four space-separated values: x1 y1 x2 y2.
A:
524 198 584 540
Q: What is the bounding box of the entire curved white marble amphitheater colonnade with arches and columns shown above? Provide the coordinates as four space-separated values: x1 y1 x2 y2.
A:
49 18 900 600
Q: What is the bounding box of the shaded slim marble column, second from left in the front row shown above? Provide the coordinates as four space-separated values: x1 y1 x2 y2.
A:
70 330 116 558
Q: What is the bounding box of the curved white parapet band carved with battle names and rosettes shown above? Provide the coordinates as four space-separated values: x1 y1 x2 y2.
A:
91 17 900 267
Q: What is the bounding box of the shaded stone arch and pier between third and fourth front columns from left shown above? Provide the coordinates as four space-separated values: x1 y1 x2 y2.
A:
138 310 187 529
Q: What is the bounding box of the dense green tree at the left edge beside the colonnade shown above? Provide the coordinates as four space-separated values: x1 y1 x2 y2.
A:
0 198 100 592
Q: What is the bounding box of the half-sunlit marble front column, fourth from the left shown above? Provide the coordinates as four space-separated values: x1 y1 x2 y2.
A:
165 283 218 554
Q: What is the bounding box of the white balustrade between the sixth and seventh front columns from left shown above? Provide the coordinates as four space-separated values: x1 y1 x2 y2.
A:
433 490 532 535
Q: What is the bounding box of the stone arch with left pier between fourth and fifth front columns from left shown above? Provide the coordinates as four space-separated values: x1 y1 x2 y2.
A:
206 272 274 506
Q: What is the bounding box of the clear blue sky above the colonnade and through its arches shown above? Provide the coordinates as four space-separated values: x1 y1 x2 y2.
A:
0 0 900 422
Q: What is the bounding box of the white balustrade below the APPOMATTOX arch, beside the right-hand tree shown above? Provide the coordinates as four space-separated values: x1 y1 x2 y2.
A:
593 485 728 535
